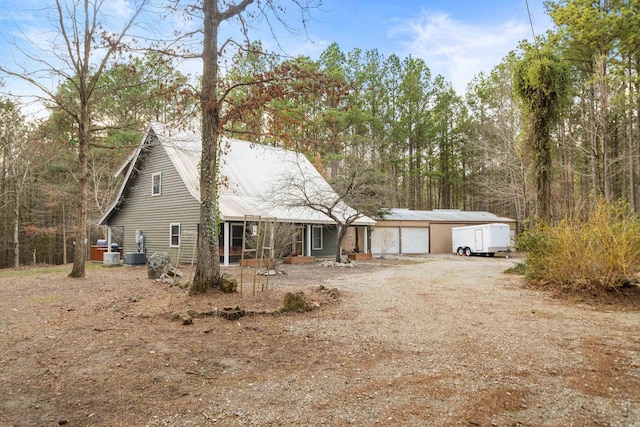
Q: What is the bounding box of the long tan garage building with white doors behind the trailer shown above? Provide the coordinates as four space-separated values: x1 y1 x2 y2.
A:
371 209 517 254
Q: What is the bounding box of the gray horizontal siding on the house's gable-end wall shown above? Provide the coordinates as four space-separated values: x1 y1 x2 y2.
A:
109 139 200 263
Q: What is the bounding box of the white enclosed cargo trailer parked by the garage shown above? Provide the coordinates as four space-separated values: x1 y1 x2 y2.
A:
451 224 512 256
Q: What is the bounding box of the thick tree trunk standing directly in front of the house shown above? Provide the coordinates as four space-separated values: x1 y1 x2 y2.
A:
190 0 220 294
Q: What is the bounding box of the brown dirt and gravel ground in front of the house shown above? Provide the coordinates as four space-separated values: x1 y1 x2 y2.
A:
0 256 640 426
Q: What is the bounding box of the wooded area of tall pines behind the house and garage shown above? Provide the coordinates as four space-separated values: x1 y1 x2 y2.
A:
0 0 640 267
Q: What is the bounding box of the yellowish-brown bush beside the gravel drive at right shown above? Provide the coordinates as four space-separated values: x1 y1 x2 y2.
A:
518 201 640 291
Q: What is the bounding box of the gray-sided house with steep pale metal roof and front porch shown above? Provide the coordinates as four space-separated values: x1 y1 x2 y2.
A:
100 123 375 265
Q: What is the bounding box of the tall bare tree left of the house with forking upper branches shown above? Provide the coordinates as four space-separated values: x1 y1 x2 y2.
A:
0 0 150 277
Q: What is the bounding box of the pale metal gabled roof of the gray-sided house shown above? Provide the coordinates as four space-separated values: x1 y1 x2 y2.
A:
100 123 375 225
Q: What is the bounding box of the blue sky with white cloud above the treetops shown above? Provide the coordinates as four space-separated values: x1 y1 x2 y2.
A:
0 0 551 113
